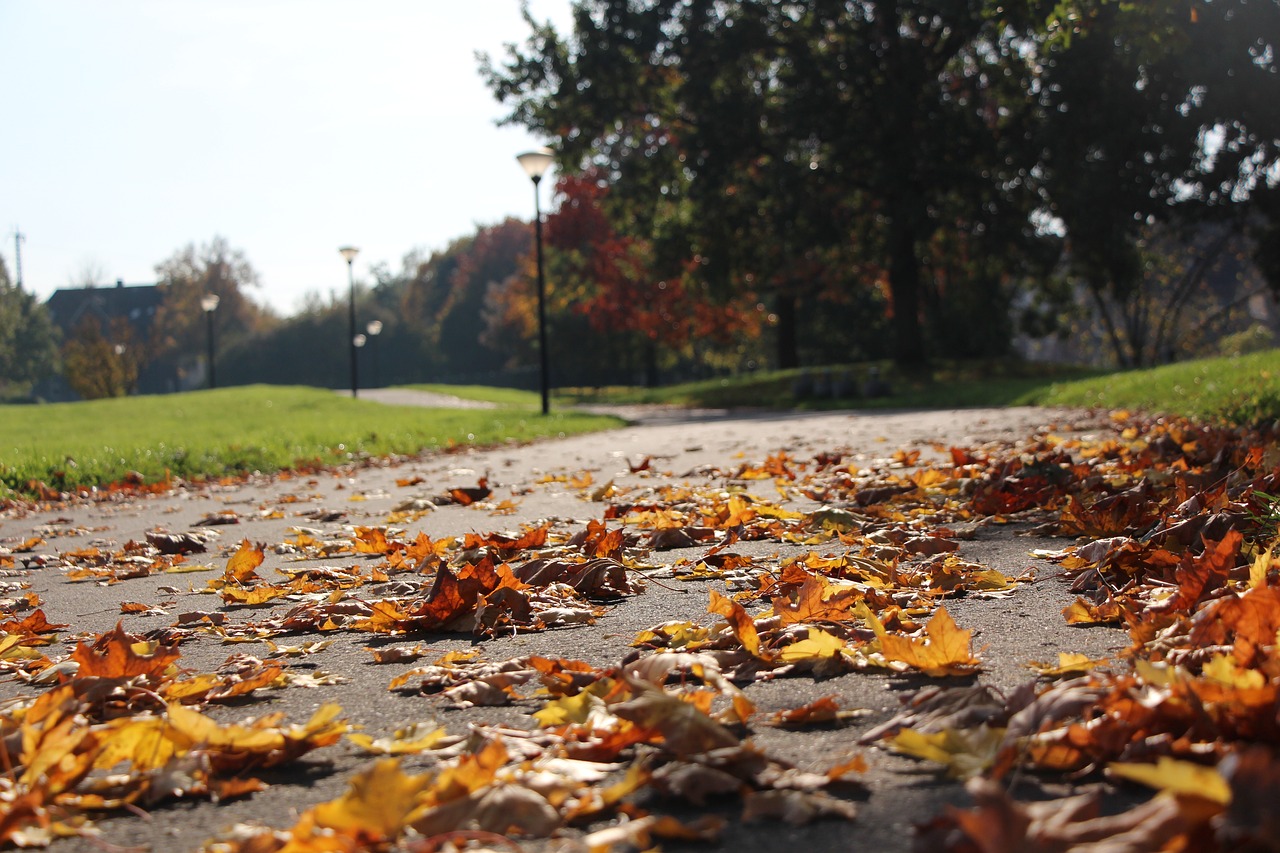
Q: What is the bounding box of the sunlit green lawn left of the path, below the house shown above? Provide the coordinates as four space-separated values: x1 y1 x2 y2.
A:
0 386 620 493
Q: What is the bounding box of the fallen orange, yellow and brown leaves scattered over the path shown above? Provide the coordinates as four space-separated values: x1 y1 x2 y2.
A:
0 415 1280 853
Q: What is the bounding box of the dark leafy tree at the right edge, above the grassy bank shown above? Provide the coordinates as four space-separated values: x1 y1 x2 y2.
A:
1033 0 1280 366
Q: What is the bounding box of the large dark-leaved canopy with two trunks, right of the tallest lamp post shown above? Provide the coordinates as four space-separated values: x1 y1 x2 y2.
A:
484 0 1052 365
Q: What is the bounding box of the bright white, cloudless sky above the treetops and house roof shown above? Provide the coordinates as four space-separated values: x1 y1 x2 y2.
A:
0 0 570 315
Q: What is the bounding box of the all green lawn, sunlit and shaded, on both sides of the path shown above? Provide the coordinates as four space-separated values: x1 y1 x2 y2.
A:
0 350 1280 496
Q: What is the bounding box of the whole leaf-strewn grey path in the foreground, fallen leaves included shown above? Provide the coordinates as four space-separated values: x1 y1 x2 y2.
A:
0 410 1280 852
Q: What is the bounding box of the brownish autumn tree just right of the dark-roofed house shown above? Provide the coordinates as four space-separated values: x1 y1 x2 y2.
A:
148 237 275 379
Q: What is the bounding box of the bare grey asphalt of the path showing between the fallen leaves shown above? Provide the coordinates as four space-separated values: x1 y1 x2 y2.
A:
0 402 1126 852
